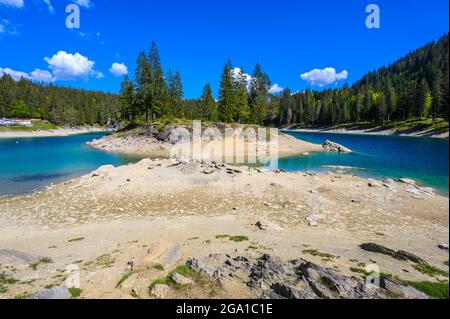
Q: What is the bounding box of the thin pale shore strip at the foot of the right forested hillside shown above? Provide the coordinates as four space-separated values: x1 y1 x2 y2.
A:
286 128 449 139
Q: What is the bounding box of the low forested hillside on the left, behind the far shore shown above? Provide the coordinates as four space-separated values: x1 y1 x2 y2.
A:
0 75 119 125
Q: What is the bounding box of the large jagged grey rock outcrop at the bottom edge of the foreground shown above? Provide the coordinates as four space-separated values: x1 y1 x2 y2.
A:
188 254 427 299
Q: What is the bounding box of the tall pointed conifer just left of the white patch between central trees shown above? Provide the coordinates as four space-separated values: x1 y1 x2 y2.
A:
218 60 236 123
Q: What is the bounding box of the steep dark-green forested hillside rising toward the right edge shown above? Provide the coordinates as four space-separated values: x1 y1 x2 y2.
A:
276 35 449 125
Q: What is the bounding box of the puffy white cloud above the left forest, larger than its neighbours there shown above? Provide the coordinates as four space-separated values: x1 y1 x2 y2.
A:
44 51 99 81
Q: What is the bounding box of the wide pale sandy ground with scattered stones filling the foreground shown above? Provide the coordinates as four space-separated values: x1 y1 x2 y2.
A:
0 159 449 298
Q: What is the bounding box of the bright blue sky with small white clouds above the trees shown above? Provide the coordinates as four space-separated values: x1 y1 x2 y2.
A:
0 0 449 98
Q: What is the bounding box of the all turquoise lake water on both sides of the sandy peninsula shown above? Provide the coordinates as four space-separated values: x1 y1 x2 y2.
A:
0 132 449 196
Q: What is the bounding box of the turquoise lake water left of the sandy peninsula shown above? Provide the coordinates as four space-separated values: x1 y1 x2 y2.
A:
0 133 138 196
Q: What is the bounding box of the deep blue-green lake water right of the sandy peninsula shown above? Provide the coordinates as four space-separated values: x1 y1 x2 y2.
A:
279 132 449 195
